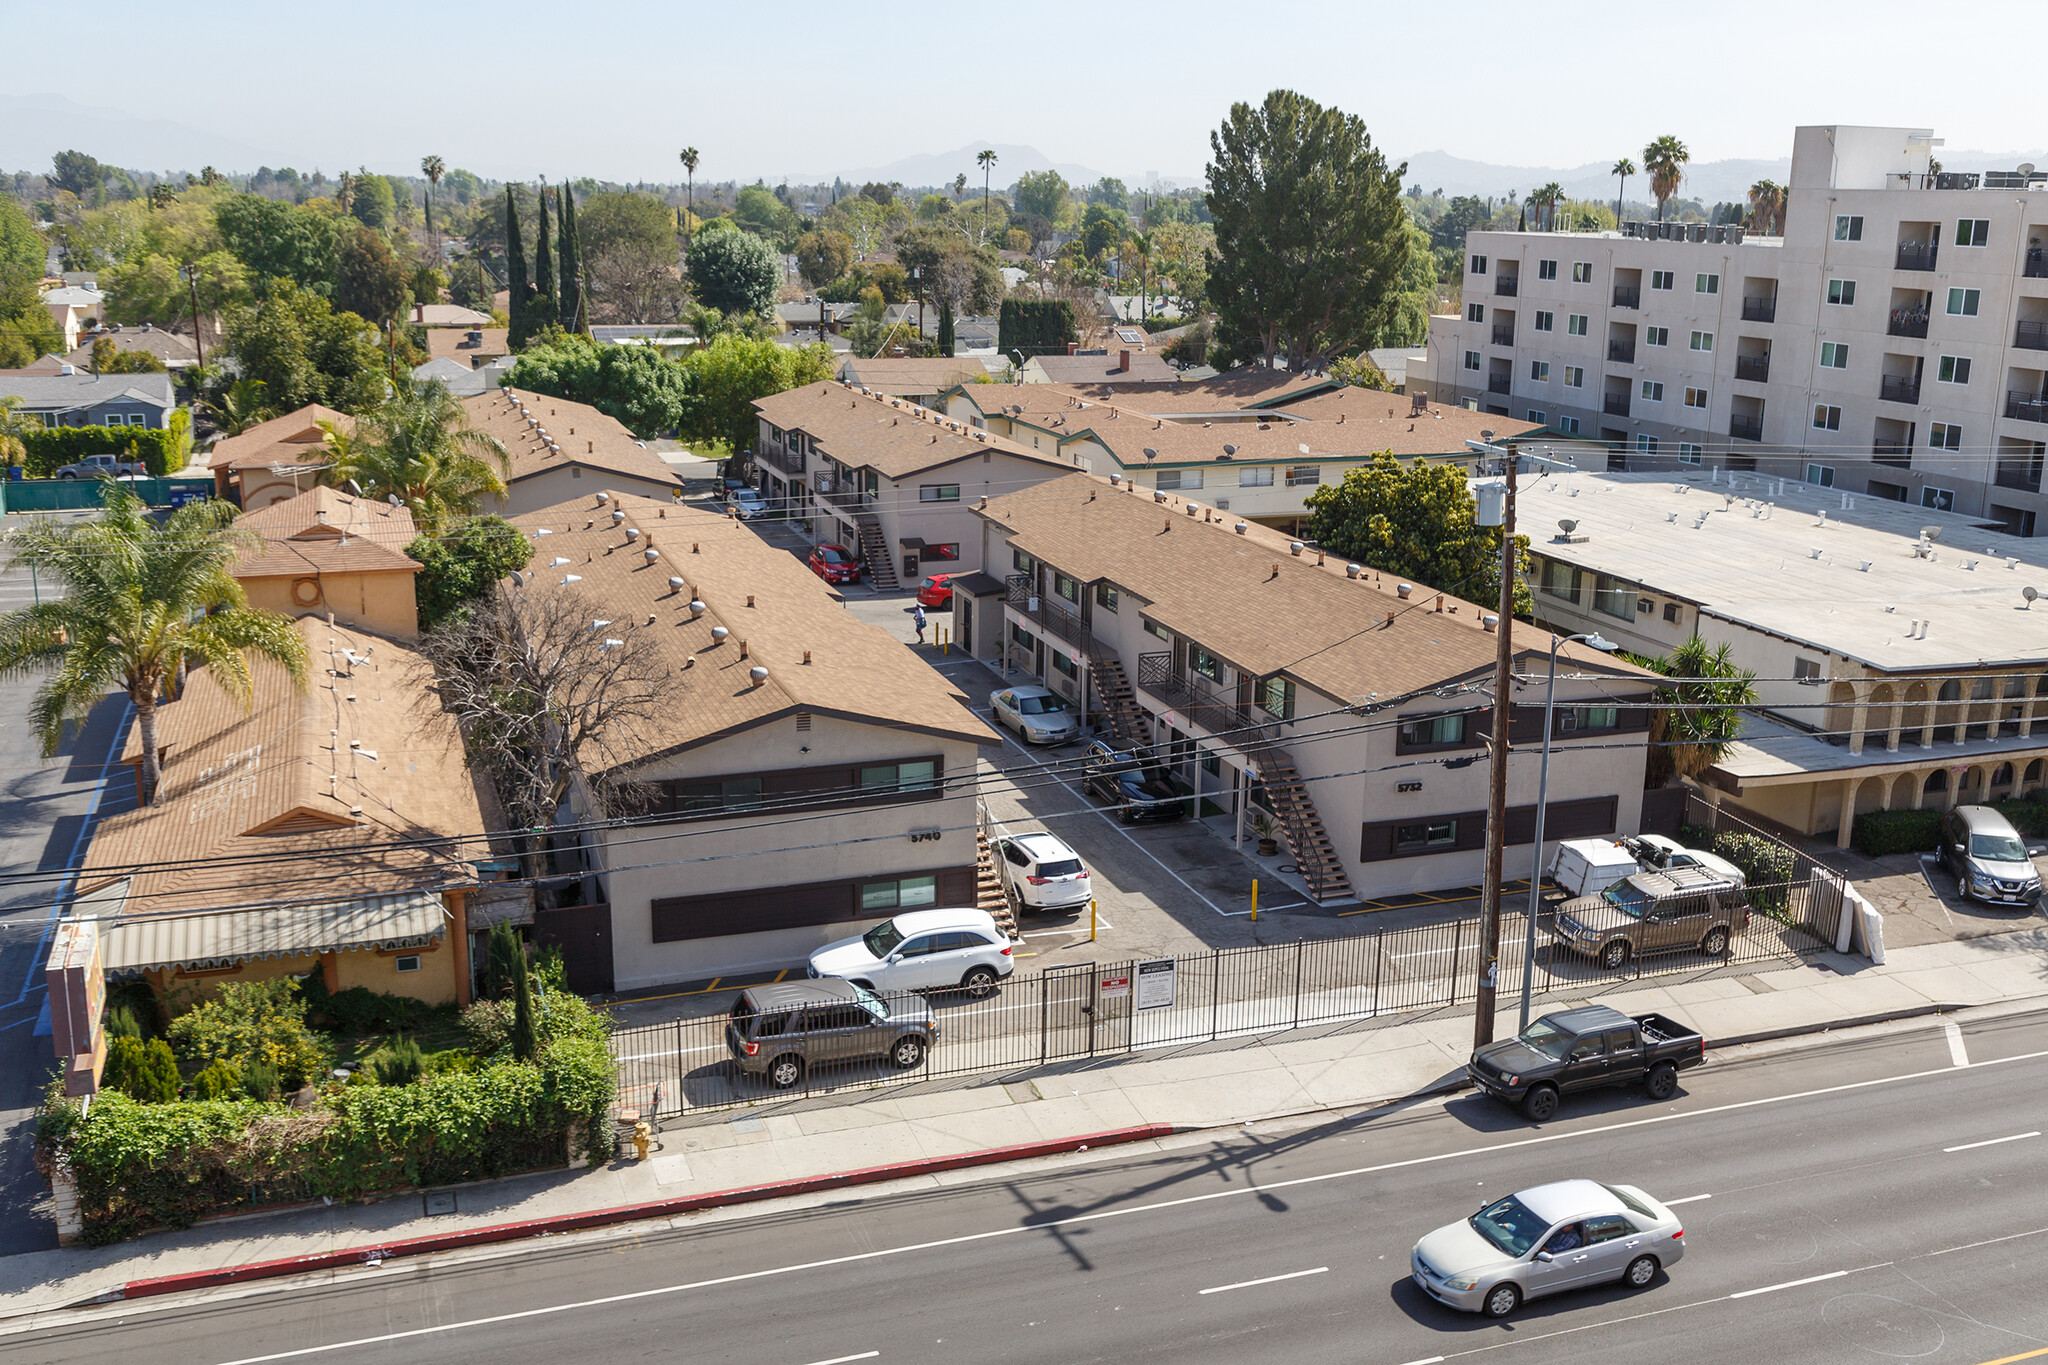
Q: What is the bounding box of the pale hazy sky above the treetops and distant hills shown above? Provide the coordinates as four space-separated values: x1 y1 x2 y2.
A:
16 0 2048 180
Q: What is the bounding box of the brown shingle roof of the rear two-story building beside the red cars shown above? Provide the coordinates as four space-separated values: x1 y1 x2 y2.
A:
754 381 1071 479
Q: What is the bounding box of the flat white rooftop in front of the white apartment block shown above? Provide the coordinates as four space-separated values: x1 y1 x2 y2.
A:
1518 471 2048 671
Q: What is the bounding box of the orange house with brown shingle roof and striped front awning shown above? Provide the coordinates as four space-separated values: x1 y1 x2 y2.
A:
74 616 494 1005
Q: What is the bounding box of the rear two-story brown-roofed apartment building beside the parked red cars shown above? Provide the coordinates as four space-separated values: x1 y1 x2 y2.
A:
754 381 1073 591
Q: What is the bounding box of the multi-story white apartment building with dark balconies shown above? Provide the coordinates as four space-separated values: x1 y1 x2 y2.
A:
1409 127 2048 536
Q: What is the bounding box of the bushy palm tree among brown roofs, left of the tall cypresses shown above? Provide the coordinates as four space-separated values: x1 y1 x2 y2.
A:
326 379 512 532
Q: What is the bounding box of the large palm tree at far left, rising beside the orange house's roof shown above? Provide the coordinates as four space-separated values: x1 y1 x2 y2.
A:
0 487 307 802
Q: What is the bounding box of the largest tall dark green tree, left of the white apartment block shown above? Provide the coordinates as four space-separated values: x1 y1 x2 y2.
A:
1208 90 1409 368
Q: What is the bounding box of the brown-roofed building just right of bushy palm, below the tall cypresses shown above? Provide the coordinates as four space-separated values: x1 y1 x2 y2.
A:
463 389 682 516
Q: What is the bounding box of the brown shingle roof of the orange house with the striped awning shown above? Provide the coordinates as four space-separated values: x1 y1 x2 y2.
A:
78 618 483 915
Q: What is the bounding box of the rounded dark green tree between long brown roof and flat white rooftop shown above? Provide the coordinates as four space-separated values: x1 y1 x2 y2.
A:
1309 450 1532 616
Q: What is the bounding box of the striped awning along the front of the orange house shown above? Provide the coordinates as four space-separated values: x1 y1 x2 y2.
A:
99 890 449 972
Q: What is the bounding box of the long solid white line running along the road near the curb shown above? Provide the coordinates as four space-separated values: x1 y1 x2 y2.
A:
167 1052 2048 1365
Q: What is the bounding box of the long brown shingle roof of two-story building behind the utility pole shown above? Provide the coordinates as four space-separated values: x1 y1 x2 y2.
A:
979 475 1647 702
